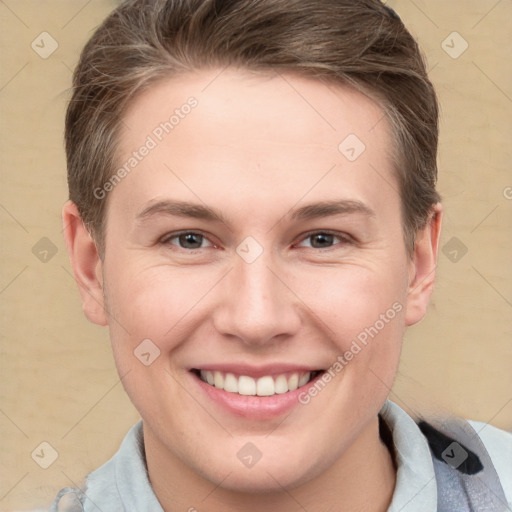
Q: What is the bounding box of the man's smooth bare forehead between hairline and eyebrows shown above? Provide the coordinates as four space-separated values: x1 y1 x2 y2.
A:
114 69 398 224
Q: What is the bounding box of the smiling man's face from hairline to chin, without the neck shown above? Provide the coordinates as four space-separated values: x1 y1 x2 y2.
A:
66 70 438 491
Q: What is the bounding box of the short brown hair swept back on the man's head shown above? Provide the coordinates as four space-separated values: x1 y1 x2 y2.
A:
65 0 439 252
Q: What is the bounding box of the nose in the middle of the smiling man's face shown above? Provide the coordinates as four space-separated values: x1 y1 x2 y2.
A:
213 255 301 347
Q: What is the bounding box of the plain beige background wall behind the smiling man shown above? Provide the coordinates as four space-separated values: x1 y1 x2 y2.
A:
0 0 512 511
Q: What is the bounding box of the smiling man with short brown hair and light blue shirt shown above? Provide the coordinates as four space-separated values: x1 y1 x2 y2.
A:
54 0 512 512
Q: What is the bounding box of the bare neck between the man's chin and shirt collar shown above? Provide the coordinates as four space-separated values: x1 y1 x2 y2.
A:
144 418 396 512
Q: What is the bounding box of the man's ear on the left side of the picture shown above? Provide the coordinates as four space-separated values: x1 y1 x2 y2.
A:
62 201 108 325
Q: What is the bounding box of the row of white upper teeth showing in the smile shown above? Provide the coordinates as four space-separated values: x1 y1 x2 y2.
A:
200 370 311 396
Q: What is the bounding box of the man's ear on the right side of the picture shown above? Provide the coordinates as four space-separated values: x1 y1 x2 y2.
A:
405 203 443 326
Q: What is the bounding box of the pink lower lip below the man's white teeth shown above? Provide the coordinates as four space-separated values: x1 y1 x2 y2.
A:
191 373 322 421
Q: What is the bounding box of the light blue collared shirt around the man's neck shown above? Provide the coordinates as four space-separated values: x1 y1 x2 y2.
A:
34 400 512 512
